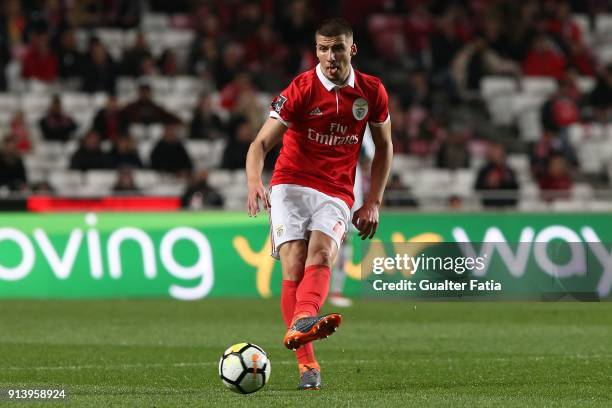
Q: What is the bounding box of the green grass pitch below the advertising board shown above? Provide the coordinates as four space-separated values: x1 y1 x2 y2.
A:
0 300 612 407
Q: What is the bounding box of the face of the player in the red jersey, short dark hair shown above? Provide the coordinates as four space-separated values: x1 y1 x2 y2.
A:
316 34 357 84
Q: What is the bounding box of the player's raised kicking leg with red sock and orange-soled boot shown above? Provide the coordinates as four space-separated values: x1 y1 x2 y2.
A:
284 230 342 349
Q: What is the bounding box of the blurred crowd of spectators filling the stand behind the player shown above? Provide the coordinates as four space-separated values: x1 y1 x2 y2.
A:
0 0 612 207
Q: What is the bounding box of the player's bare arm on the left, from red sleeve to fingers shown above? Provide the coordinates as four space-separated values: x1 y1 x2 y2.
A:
246 118 287 217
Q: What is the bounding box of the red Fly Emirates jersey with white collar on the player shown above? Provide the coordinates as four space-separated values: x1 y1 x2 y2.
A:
270 65 389 208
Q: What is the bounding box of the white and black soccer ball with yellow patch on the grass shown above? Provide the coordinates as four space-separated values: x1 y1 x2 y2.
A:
219 343 272 394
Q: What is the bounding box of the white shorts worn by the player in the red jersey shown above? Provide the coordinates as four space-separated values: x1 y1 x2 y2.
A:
270 184 350 259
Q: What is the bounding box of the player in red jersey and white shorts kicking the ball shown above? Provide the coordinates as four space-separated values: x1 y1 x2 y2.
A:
246 18 393 389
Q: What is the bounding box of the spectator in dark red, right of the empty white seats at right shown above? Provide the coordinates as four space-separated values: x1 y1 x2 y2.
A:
540 77 580 132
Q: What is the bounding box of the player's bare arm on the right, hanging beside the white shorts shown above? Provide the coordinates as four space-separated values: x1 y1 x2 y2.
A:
353 119 393 239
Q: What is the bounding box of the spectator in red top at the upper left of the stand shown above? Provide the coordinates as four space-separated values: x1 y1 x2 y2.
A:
21 29 58 82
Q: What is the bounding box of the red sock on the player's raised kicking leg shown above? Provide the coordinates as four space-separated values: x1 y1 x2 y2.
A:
293 265 331 319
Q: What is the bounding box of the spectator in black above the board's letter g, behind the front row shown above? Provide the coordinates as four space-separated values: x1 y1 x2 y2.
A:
151 124 193 177
